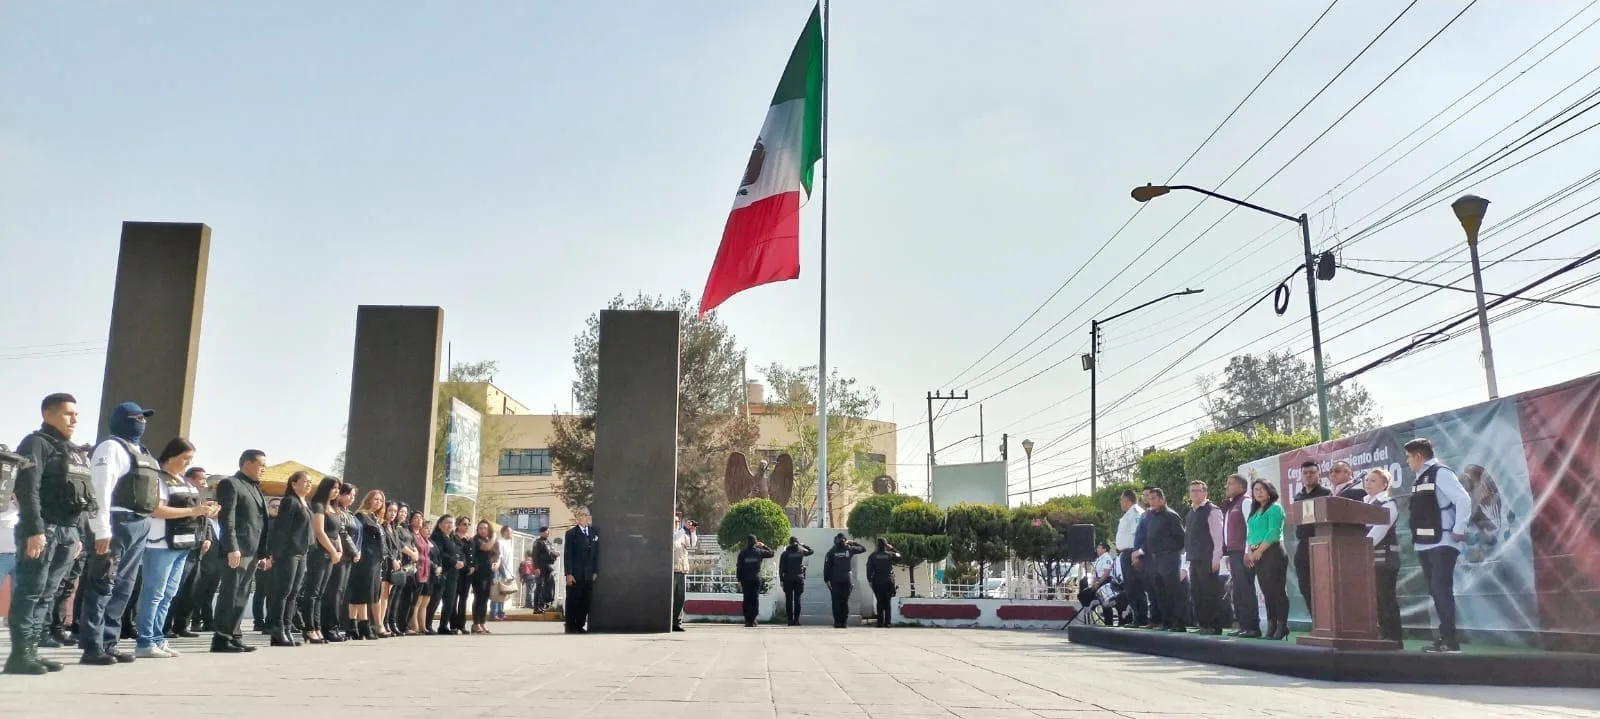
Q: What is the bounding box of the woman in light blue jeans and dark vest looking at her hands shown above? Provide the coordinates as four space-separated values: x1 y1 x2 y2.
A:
134 437 218 658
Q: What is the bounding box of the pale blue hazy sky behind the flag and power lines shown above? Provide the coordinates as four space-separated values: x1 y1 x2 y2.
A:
0 0 1600 506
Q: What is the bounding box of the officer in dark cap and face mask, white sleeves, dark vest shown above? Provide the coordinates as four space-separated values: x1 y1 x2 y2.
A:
78 402 162 666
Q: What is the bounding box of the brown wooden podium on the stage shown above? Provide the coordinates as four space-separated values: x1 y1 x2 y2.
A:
1288 496 1400 650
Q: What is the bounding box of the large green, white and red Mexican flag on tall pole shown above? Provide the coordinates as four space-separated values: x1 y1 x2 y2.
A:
699 8 822 315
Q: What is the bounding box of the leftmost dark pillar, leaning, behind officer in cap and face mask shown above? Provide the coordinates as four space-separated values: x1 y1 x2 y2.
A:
94 223 211 452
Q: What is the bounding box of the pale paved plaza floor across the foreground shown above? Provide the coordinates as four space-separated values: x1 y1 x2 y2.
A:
0 623 1600 719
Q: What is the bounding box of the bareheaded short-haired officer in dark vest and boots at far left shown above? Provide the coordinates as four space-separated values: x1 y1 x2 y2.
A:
5 394 94 674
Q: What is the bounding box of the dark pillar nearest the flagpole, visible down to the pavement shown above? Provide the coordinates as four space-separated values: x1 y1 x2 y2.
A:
589 311 678 633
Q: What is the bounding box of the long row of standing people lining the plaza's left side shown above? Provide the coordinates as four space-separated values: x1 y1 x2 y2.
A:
0 394 558 674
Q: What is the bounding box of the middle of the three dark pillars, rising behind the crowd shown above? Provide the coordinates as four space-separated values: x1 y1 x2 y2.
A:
344 304 445 508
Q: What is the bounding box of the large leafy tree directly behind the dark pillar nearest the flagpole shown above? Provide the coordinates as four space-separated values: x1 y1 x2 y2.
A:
549 291 758 525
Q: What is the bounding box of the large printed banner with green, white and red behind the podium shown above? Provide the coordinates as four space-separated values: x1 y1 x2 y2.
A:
1238 369 1600 649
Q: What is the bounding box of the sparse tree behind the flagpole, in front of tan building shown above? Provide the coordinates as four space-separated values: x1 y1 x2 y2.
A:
762 364 885 527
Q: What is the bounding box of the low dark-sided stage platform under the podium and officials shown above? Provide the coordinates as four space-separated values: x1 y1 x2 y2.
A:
1067 625 1600 689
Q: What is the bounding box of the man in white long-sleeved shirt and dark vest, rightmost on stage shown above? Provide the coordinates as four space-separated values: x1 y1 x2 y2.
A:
1405 439 1472 653
